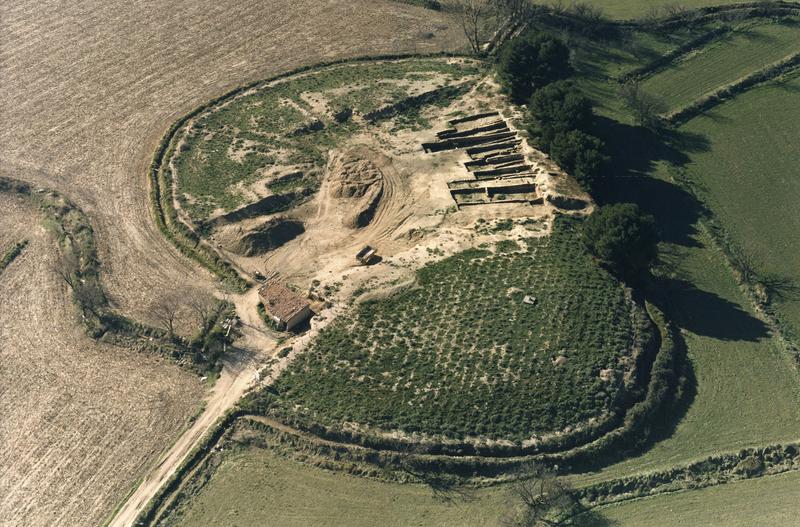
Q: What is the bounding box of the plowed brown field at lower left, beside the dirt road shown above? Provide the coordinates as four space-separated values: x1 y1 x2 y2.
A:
0 195 204 525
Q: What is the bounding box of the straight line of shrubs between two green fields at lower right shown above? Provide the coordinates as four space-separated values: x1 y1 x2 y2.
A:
577 443 800 507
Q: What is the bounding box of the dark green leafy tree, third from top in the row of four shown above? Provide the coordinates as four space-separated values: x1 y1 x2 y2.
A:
550 130 608 190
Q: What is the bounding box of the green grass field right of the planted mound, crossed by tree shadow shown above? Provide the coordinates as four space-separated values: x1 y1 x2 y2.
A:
576 221 800 485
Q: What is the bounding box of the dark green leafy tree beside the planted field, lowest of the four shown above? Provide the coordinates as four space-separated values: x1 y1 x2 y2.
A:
583 203 658 279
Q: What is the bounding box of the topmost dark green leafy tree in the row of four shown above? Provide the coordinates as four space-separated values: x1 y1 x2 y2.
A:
497 32 572 103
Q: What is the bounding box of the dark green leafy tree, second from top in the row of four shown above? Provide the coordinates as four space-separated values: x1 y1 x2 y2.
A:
526 81 593 150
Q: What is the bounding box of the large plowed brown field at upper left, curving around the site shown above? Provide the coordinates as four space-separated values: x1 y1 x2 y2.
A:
0 0 462 326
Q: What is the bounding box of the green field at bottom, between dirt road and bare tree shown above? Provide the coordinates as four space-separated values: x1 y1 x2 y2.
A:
167 448 507 527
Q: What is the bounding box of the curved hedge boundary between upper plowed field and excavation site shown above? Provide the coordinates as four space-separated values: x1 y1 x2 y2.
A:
147 52 472 292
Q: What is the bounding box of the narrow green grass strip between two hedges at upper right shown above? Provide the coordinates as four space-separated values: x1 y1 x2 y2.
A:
642 22 800 110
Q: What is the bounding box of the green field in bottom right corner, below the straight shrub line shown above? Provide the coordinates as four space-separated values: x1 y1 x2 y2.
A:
601 472 800 527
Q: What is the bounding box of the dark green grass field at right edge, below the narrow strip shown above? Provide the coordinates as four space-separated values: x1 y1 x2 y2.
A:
684 77 800 330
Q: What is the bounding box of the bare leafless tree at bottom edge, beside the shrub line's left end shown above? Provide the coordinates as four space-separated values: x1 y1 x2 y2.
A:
504 463 578 527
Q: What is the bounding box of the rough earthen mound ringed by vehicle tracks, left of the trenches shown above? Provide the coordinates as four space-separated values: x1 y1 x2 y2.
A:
327 147 391 229
